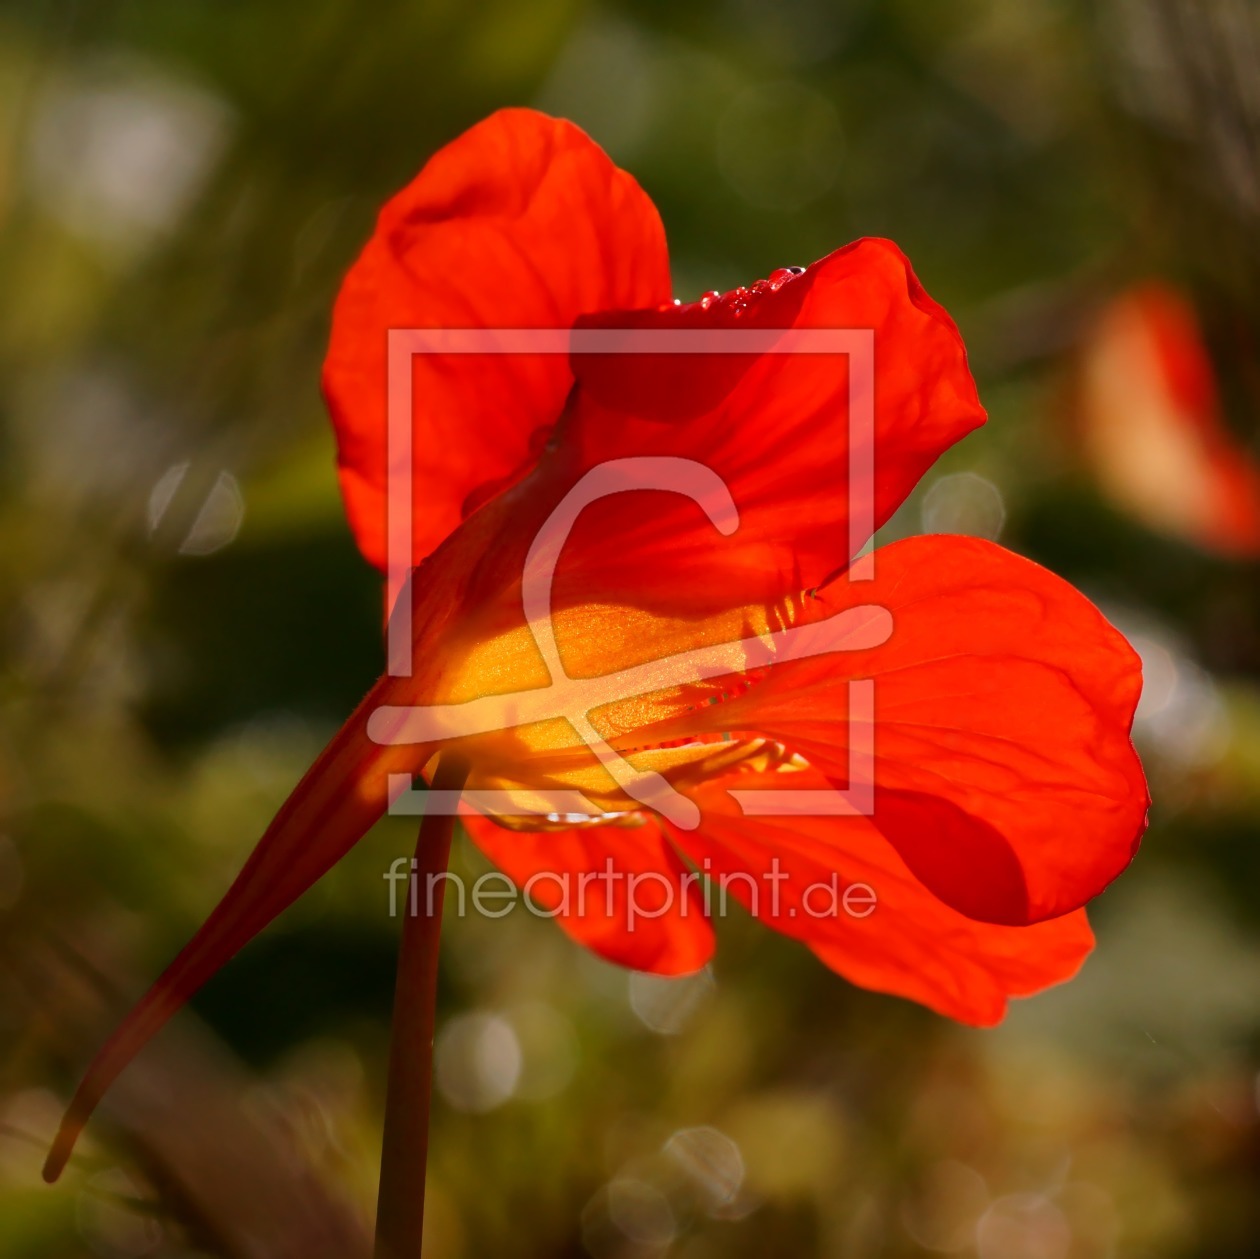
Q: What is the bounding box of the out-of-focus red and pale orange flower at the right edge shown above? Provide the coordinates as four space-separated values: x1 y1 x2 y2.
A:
1077 280 1260 557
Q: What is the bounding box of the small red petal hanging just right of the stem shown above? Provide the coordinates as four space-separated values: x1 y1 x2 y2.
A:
464 815 713 975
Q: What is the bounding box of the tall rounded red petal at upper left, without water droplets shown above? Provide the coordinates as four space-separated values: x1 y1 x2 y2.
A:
324 110 670 599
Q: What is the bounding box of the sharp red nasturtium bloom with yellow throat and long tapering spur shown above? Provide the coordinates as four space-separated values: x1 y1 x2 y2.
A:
46 110 1148 1179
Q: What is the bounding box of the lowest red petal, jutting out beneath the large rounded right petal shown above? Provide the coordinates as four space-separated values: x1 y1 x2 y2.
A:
672 774 1094 1027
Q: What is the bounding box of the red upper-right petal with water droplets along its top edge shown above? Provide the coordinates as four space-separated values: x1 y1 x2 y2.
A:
539 239 984 615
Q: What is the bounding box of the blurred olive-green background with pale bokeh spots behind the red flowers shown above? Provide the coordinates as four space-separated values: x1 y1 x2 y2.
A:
0 0 1260 1259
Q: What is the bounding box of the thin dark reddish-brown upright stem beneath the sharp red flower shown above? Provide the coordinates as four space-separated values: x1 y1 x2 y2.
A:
374 754 469 1259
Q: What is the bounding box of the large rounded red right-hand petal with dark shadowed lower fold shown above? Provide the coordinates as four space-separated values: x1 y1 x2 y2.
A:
649 537 1149 924
